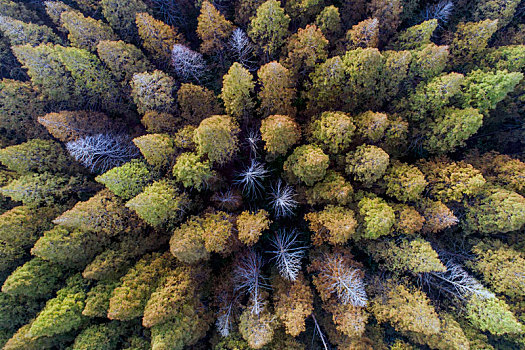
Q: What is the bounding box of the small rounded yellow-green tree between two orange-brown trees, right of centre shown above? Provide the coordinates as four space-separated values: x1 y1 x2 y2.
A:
357 197 396 239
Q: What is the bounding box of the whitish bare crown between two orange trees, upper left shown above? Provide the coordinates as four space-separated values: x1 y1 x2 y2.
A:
171 44 206 82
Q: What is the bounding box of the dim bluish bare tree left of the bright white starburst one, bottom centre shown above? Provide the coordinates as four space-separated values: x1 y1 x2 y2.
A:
234 250 267 315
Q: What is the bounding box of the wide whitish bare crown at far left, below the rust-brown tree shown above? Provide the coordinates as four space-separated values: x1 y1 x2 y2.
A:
66 134 139 172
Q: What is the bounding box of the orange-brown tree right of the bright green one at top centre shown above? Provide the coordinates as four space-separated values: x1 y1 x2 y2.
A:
283 25 329 81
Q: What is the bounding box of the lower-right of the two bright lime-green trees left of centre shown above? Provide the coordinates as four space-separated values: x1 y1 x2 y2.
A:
126 179 189 227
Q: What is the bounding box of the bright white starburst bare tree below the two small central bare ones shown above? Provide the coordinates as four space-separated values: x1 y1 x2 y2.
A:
268 230 305 281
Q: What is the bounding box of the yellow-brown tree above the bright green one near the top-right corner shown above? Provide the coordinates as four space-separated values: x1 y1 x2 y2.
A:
450 19 498 67
